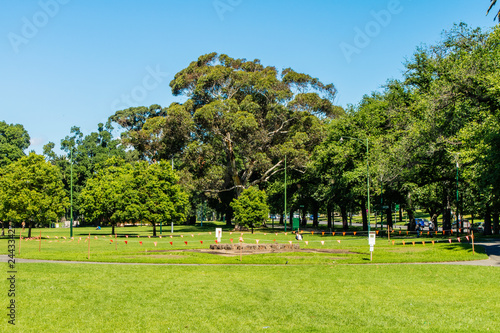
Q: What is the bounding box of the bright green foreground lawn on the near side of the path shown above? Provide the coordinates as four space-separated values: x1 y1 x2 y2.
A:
0 263 500 332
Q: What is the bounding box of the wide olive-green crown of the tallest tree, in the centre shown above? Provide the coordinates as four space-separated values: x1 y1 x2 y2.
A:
112 53 343 221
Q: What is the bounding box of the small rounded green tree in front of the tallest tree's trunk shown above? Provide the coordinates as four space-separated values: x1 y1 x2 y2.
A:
231 187 269 228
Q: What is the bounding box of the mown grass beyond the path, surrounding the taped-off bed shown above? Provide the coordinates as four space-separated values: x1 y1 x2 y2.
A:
0 227 487 265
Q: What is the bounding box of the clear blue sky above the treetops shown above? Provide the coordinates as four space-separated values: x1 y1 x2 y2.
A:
0 0 498 153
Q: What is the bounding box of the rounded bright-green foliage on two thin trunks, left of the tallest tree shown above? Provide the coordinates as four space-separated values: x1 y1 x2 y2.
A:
81 159 188 235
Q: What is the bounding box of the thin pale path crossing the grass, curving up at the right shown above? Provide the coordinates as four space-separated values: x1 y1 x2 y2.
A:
0 239 500 267
